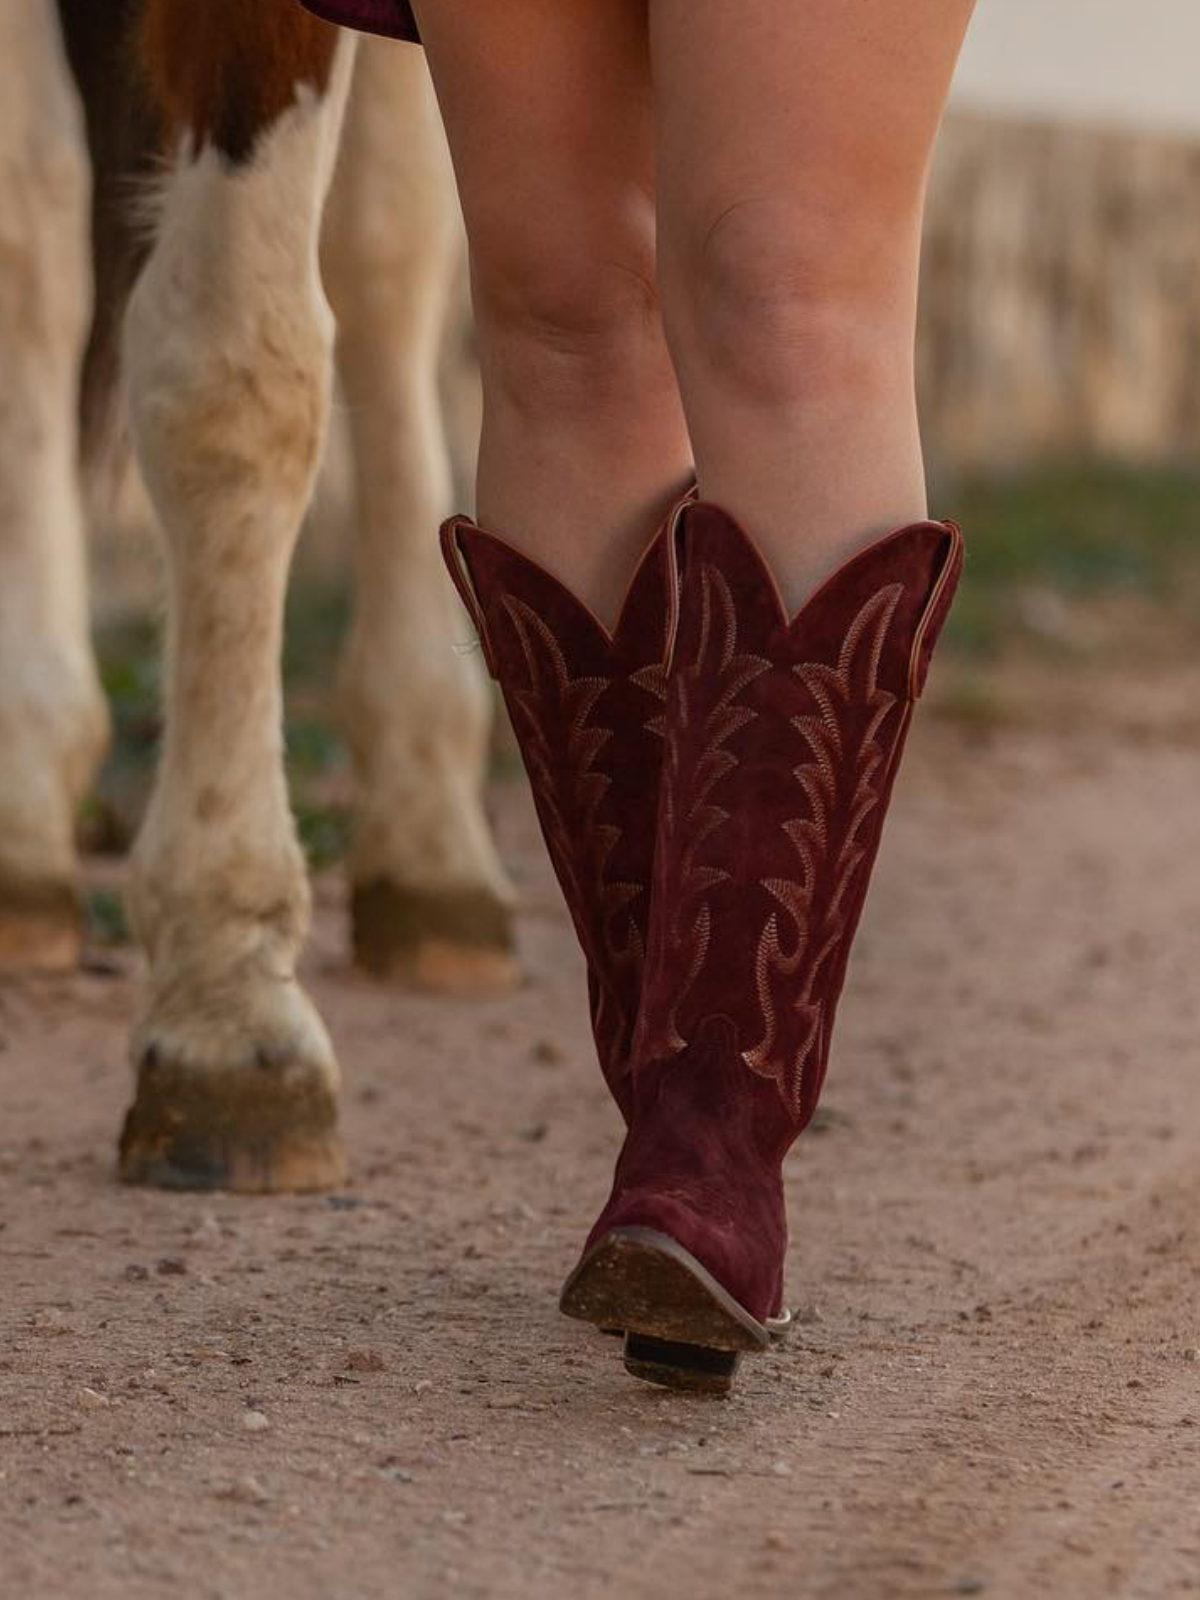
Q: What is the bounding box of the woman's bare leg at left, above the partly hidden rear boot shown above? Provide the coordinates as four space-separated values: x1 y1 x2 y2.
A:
416 0 690 621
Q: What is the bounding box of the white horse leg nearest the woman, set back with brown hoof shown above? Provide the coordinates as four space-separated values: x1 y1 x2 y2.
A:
323 42 515 989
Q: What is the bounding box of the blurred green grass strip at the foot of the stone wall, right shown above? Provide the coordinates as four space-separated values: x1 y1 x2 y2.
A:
942 462 1200 654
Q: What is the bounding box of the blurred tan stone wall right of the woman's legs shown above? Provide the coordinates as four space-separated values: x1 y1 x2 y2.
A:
918 112 1200 472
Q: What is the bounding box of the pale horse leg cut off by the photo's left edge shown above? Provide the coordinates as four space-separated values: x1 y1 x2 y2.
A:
0 3 107 968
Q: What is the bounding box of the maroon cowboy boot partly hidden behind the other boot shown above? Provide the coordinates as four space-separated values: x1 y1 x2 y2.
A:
442 507 680 1122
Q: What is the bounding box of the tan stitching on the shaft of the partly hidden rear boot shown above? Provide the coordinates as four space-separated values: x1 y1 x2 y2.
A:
502 595 666 1074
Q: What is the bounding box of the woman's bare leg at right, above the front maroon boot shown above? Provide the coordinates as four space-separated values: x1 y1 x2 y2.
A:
650 0 973 608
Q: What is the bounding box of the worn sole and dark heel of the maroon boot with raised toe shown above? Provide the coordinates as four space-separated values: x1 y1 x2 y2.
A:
558 1227 771 1395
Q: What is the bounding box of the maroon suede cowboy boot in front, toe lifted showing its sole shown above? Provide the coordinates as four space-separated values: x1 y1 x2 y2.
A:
562 502 962 1392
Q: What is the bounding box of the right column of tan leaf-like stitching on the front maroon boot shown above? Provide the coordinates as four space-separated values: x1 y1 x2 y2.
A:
742 584 904 1117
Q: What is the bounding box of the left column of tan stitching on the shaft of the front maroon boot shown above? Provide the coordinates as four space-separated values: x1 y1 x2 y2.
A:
635 563 771 1059
